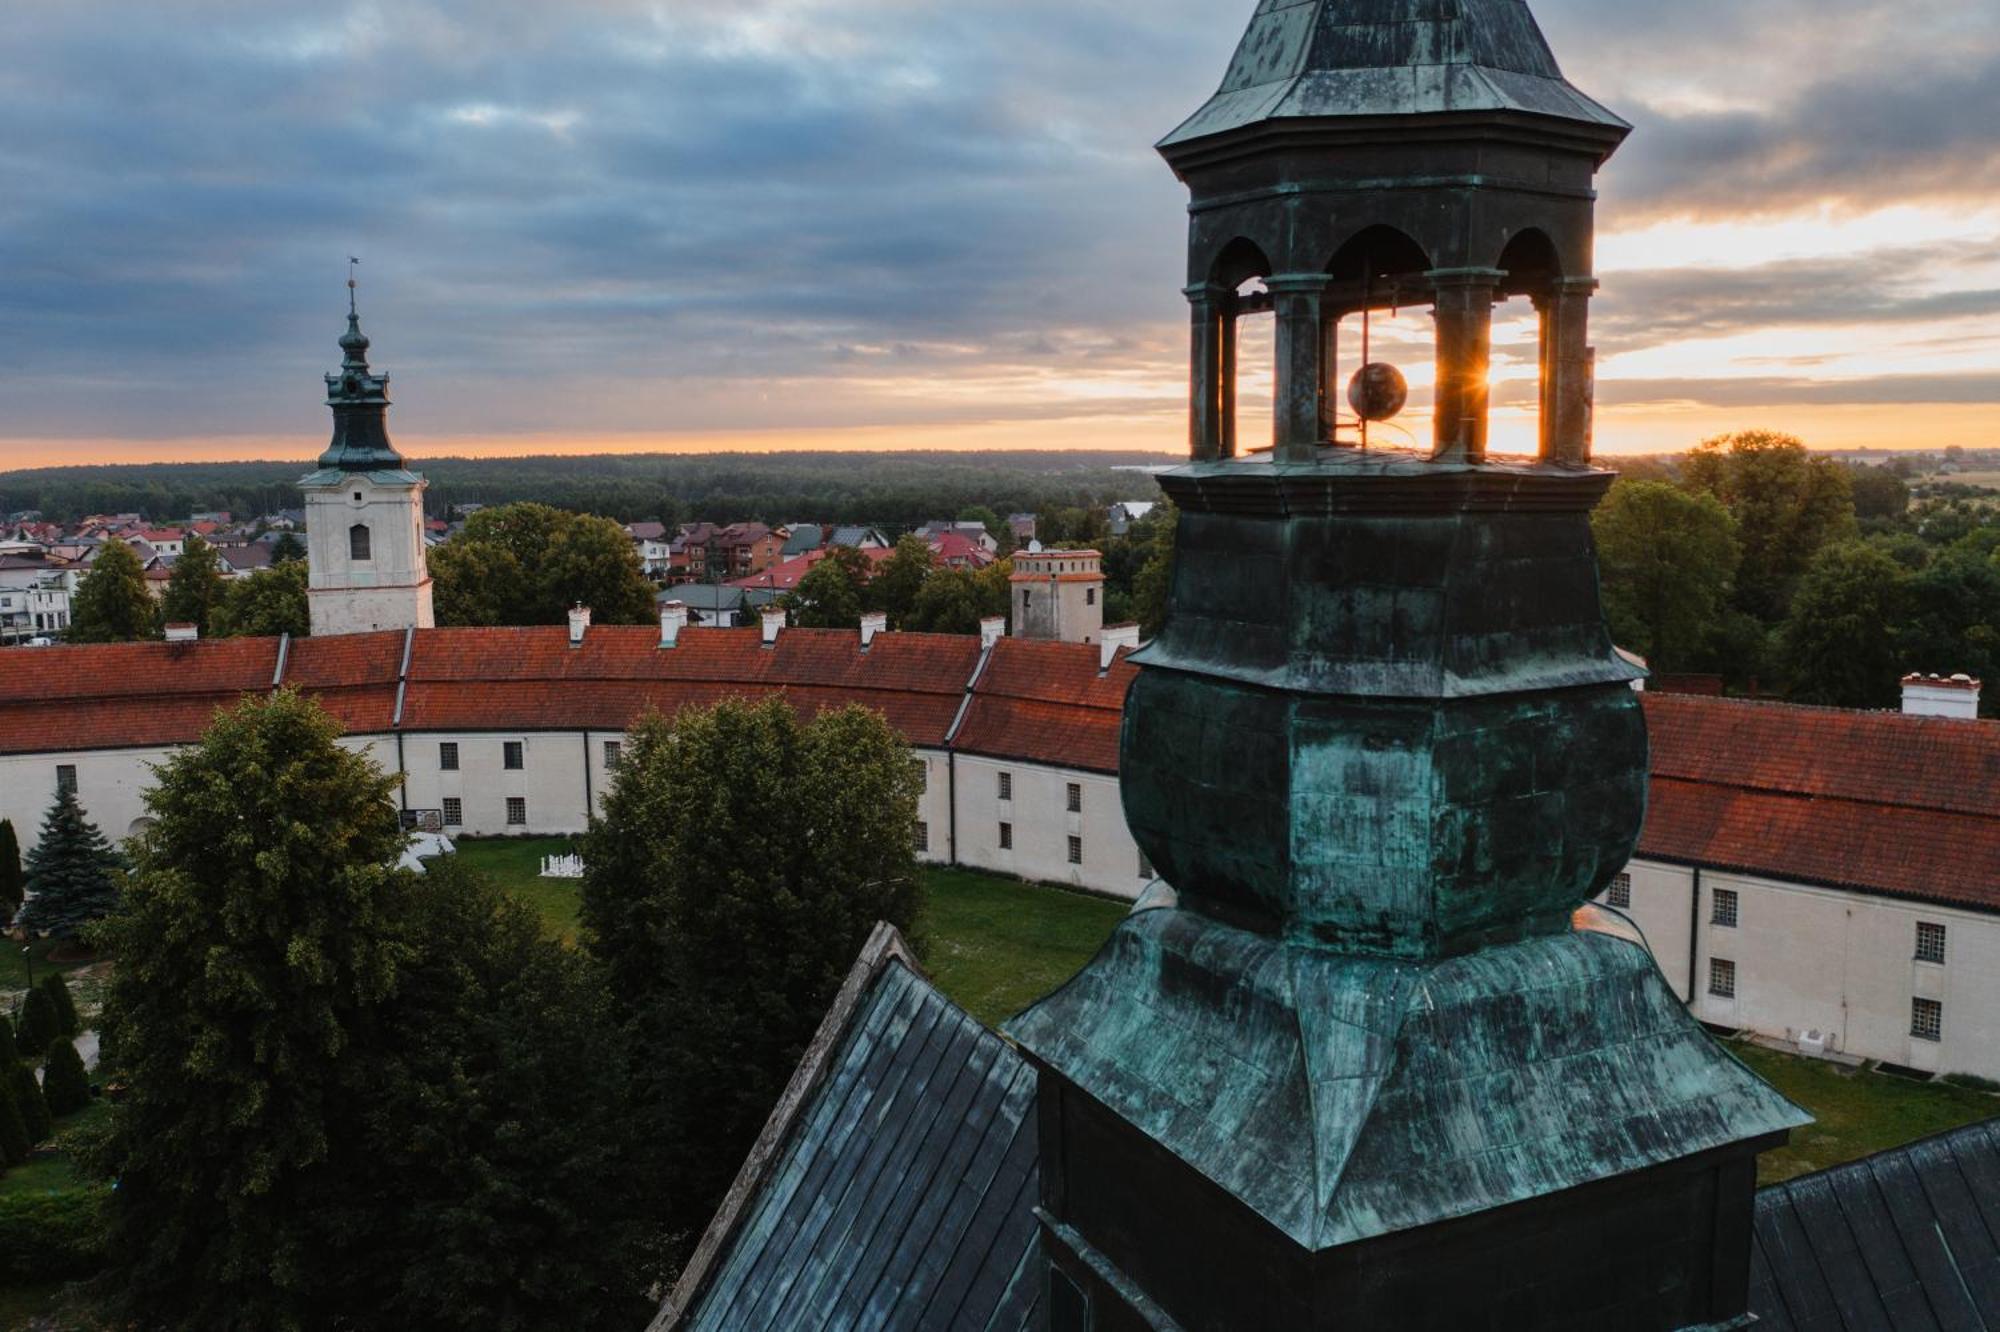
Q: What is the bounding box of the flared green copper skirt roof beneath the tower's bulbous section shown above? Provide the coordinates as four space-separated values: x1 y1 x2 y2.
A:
1006 892 1810 1252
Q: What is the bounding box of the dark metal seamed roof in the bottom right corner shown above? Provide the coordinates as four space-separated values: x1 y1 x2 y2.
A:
1750 1120 2000 1332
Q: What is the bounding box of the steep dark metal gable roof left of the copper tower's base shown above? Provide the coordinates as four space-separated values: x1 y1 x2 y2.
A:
652 926 1042 1332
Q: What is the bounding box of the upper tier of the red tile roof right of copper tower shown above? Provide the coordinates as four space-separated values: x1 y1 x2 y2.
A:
1646 694 2000 818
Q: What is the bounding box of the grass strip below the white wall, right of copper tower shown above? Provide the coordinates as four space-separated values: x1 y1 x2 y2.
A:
1730 1042 2000 1184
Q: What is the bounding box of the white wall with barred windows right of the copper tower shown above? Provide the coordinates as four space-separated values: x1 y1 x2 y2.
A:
1600 860 2000 1078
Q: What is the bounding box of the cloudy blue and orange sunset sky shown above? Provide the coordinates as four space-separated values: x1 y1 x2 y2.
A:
0 0 2000 466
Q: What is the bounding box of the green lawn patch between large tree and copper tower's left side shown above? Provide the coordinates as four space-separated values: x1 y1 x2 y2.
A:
924 870 1130 1026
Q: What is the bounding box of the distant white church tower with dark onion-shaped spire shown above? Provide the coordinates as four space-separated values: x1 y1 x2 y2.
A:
298 278 434 638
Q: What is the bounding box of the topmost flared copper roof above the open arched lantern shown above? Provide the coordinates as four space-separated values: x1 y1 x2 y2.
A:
1160 0 1628 148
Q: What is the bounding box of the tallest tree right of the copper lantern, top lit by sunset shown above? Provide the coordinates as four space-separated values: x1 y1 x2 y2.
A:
1682 430 1856 624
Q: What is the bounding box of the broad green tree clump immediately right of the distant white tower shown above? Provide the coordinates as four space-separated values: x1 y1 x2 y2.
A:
430 502 656 624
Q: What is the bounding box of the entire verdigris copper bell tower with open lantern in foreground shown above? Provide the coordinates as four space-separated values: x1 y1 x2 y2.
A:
1010 0 1806 1332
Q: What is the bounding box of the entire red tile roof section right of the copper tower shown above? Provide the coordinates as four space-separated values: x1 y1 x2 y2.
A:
1640 694 2000 910
